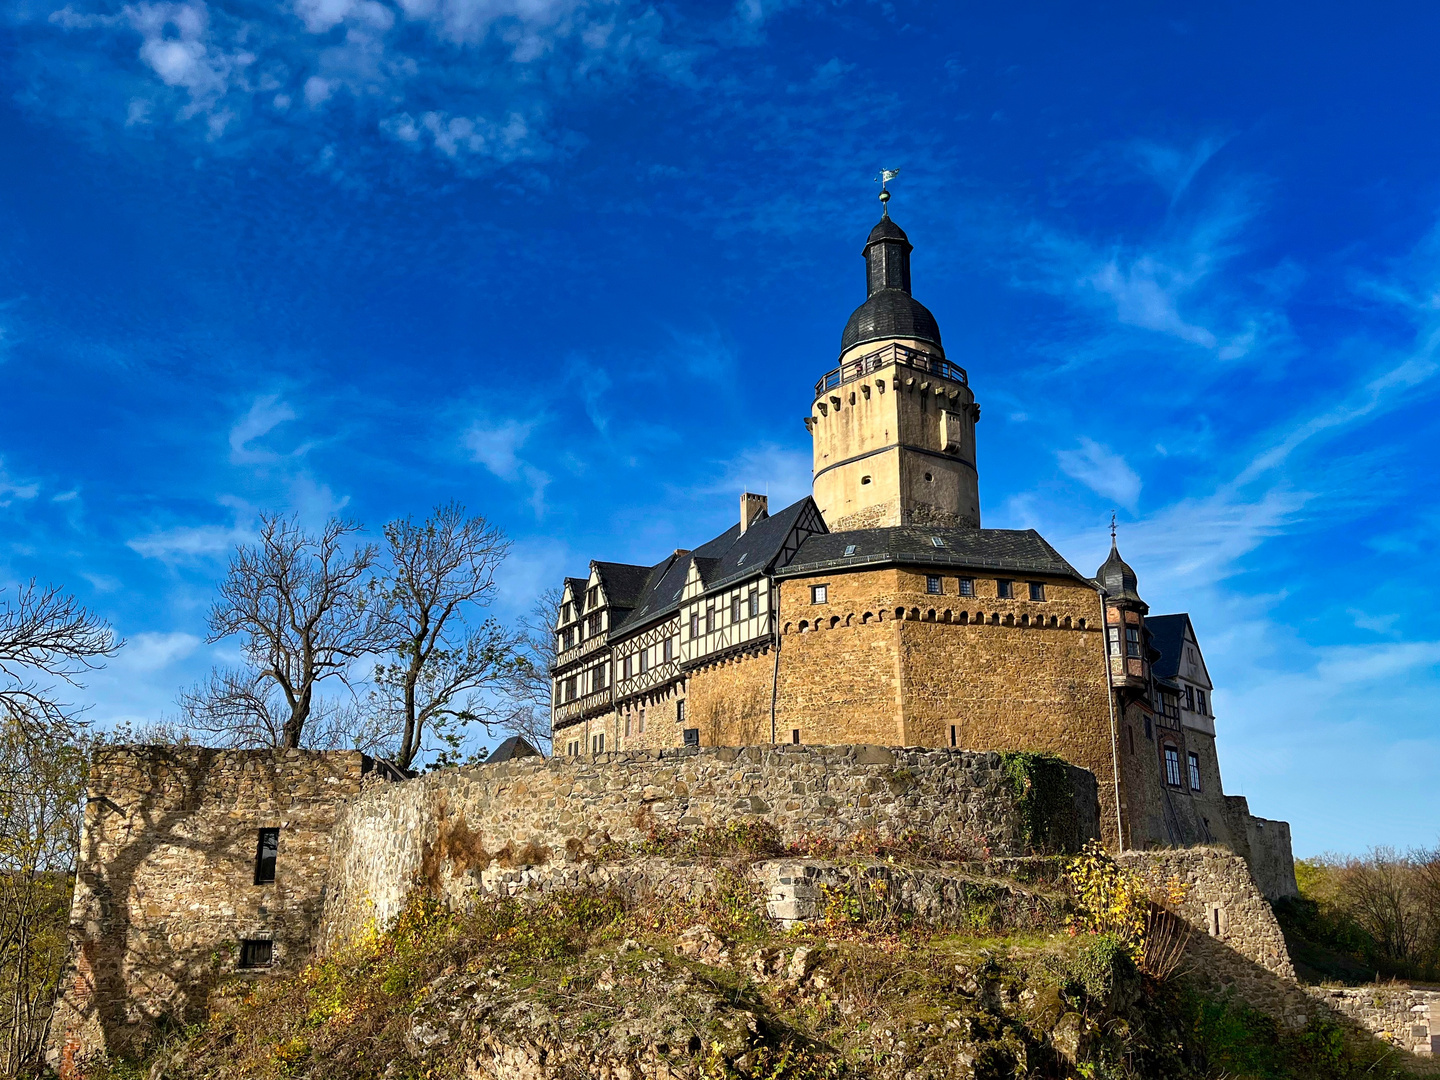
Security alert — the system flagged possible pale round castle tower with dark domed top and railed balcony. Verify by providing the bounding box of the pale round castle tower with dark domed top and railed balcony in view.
[805,201,981,531]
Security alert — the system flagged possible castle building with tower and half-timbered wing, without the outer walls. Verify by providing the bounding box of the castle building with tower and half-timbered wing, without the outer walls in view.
[552,193,1295,896]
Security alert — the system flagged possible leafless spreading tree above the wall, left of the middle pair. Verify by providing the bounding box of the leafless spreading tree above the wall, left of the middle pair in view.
[180,514,383,749]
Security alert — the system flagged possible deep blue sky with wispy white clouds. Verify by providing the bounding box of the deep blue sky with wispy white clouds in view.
[0,0,1440,854]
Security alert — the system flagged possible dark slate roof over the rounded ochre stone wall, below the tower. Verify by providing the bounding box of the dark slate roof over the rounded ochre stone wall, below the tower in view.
[775,526,1090,583]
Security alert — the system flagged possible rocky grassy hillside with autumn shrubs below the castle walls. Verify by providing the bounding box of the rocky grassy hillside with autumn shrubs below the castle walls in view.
[91,844,1422,1080]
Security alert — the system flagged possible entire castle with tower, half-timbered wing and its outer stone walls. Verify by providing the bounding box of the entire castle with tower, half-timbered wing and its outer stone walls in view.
[49,194,1313,1076]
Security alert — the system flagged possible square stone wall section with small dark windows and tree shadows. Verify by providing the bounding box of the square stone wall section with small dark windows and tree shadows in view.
[50,746,372,1071]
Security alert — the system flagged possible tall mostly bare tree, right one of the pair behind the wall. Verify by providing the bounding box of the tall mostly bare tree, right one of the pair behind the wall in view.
[374,503,521,769]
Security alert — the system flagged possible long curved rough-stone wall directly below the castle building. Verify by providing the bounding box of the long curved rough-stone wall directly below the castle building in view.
[320,746,1096,949]
